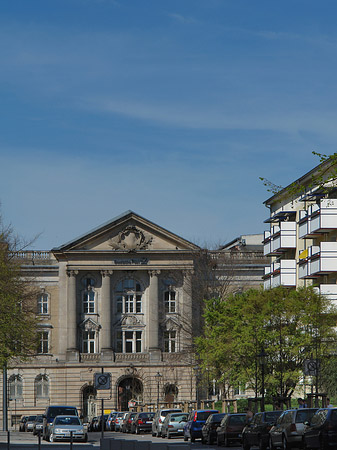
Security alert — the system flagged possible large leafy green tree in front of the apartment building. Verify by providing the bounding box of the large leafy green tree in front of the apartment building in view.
[196,287,336,397]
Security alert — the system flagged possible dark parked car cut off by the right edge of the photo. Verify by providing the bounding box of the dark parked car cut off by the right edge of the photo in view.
[303,408,337,450]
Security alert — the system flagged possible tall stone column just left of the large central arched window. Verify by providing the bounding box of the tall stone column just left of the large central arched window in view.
[99,270,113,361]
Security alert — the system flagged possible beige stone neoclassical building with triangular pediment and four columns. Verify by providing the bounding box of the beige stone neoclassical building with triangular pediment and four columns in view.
[1,211,263,426]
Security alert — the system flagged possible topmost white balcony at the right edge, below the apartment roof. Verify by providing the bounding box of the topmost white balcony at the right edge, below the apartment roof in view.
[299,198,337,239]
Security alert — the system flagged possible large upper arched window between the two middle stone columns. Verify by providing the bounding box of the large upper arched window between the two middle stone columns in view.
[116,278,143,314]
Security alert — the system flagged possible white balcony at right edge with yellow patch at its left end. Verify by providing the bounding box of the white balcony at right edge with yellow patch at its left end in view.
[298,242,337,278]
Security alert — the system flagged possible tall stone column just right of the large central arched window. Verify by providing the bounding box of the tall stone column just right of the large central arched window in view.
[147,270,161,360]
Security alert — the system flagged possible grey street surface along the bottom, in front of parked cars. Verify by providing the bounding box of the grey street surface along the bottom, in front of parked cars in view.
[0,431,241,450]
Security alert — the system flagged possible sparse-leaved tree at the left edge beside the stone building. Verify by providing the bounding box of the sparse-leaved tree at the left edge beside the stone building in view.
[0,218,37,367]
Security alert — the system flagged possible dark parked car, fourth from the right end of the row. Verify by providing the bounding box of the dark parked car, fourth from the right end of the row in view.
[216,413,247,447]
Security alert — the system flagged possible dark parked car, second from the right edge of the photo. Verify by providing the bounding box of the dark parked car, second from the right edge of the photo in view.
[269,408,318,450]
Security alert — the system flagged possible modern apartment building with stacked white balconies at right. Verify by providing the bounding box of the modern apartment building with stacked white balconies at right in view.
[263,161,337,300]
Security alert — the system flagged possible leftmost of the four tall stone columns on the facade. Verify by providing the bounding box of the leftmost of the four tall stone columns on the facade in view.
[67,270,79,360]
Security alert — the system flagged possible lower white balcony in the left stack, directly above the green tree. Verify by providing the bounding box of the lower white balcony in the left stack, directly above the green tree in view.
[264,259,296,289]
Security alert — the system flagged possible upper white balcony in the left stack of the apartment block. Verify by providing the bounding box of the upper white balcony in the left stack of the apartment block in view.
[263,222,296,256]
